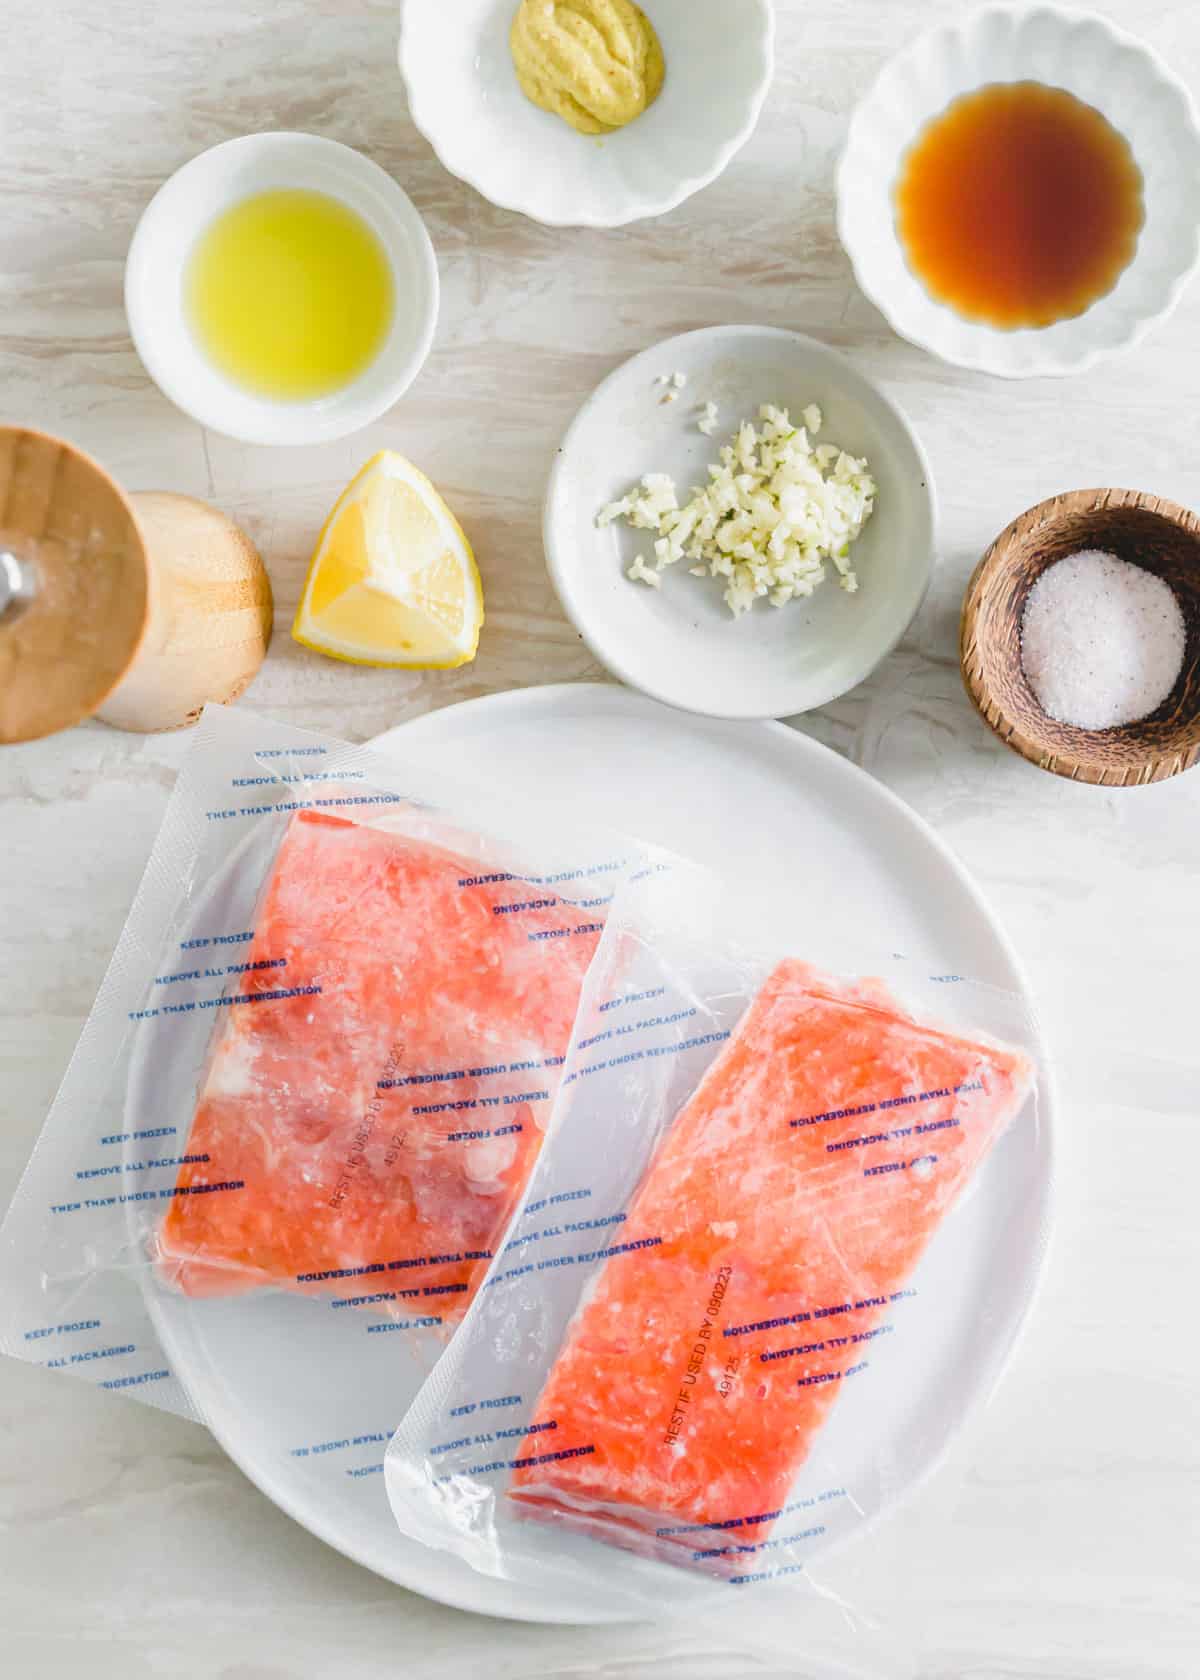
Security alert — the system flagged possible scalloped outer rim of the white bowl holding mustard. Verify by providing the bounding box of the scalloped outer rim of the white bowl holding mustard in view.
[397,0,775,228]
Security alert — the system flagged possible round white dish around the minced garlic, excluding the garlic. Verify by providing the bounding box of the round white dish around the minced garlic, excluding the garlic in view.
[543,326,934,717]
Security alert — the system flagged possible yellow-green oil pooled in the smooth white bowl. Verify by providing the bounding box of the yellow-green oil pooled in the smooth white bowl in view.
[183,188,393,402]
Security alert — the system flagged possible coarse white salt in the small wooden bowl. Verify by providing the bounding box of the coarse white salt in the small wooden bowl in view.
[1020,548,1187,729]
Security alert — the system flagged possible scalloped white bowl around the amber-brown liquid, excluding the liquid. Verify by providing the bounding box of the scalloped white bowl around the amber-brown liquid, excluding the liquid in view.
[837,5,1200,378]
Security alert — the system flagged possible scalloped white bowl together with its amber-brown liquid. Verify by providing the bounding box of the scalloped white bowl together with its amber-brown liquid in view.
[837,3,1200,378]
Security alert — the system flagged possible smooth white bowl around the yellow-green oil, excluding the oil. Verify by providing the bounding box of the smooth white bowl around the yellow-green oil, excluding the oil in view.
[124,133,439,444]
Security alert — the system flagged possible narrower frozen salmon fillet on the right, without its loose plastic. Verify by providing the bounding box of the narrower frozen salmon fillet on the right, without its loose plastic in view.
[511,961,1034,1567]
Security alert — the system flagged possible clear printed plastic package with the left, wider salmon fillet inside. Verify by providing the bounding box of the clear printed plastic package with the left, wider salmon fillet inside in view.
[0,707,640,1424]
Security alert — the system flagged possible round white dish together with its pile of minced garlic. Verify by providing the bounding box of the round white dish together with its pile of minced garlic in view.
[543,326,934,717]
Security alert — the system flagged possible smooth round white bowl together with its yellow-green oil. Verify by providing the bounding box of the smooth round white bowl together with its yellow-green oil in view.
[124,133,439,444]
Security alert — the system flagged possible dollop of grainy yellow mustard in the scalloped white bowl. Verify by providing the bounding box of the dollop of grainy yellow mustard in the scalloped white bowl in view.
[509,0,664,134]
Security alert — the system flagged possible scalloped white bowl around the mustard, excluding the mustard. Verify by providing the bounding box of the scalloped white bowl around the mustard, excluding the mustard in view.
[400,0,775,227]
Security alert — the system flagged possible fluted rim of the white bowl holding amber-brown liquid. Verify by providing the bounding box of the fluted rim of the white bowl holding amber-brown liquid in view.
[835,3,1200,380]
